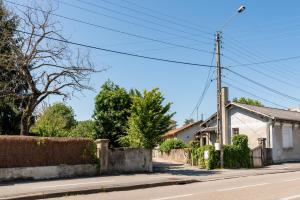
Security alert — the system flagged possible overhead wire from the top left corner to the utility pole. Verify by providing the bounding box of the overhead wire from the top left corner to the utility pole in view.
[4,0,213,54]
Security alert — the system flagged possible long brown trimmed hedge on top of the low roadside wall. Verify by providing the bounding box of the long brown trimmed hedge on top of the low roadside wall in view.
[0,136,96,168]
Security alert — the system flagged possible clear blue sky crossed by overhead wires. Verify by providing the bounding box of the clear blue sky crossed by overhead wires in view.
[15,0,300,124]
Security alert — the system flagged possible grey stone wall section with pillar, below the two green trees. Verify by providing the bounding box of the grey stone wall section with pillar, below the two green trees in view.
[96,140,152,174]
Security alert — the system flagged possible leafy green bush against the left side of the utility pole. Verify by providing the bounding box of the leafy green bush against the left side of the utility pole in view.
[191,145,218,169]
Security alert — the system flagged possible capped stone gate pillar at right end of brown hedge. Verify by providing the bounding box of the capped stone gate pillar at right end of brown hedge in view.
[96,139,109,174]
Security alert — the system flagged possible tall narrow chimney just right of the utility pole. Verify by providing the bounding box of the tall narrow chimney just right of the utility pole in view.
[221,87,231,144]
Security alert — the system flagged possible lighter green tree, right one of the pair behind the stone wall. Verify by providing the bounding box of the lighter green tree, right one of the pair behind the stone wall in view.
[120,88,175,148]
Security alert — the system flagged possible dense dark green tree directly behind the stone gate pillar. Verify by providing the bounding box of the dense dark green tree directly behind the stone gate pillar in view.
[93,81,135,147]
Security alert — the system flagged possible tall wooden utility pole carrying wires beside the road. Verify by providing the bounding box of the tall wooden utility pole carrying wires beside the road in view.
[216,31,224,168]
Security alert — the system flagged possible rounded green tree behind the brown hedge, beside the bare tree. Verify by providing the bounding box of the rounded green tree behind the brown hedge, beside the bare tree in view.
[31,103,76,137]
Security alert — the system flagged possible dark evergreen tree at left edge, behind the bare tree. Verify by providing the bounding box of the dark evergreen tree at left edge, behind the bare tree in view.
[0,0,23,134]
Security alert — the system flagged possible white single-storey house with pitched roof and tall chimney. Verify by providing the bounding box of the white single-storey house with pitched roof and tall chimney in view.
[196,88,300,163]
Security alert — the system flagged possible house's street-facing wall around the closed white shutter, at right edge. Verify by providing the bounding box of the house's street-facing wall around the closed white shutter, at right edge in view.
[272,123,300,163]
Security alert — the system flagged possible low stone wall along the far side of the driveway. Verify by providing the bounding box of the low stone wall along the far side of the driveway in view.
[153,149,190,164]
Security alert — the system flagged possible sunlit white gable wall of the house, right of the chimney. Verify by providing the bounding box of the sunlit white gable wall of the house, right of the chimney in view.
[228,107,268,149]
